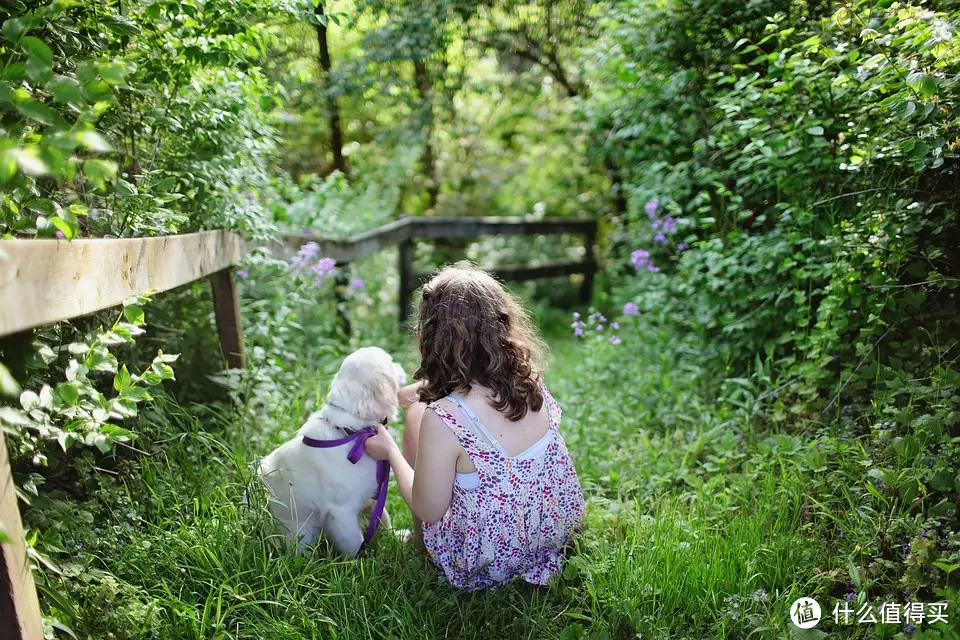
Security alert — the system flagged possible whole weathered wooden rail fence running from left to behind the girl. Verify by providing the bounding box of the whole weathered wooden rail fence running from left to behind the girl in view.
[0,218,597,640]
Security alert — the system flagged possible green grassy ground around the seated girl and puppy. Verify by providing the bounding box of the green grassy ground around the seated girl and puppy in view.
[31,316,956,640]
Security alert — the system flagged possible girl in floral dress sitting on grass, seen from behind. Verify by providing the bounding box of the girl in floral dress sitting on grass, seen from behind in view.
[366,263,584,589]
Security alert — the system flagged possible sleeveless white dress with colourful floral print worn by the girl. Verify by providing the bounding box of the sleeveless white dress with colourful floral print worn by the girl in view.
[423,387,584,590]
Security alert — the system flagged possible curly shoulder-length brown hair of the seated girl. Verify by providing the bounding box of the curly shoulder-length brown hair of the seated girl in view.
[413,262,544,422]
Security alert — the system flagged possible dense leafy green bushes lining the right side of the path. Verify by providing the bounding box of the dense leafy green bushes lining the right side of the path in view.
[591,0,960,620]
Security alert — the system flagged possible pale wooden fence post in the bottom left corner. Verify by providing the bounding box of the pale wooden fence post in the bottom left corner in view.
[0,431,43,640]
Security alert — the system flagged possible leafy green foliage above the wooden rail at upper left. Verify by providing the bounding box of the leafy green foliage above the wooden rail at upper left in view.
[0,0,298,239]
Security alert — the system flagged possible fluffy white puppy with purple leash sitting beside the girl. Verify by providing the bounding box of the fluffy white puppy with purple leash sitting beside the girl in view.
[260,347,406,555]
